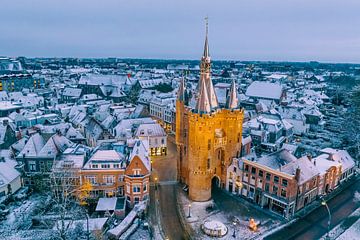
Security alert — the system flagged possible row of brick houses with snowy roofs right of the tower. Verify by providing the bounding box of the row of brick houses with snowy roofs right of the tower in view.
[226,148,356,218]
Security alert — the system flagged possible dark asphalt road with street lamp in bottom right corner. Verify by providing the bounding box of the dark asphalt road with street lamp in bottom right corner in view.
[265,180,360,240]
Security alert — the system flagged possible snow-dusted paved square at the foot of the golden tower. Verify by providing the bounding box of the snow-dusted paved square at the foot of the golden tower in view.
[177,187,281,240]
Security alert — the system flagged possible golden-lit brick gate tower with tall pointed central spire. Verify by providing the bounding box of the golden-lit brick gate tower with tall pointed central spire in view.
[176,19,244,201]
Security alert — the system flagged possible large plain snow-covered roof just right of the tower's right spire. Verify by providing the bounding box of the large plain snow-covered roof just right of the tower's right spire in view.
[245,81,283,100]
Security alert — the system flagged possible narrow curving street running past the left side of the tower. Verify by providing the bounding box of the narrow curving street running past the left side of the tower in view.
[151,136,186,240]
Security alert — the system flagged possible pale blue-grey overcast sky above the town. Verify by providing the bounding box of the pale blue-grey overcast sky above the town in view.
[0,0,360,63]
